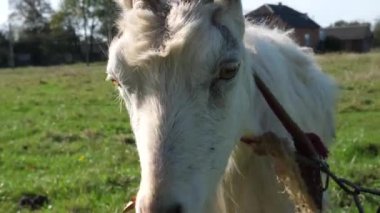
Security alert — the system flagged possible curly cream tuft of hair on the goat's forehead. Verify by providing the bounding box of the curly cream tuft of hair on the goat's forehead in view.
[110,4,222,65]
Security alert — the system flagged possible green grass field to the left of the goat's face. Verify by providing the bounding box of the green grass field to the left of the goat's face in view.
[0,64,139,212]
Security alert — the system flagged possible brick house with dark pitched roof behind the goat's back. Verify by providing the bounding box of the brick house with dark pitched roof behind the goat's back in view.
[245,3,321,49]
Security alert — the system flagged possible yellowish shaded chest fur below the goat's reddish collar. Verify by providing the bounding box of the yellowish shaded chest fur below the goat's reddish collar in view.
[217,144,294,213]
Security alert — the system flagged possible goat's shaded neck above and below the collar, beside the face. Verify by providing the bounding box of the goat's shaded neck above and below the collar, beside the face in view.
[217,60,294,213]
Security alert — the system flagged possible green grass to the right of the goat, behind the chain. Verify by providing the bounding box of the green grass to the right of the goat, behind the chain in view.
[318,51,380,212]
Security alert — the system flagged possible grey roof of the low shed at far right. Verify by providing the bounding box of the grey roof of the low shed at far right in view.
[323,25,372,40]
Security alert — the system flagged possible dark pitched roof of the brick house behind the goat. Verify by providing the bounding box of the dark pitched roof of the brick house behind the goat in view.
[245,3,320,28]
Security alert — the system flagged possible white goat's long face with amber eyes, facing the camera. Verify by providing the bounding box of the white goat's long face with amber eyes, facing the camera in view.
[107,1,247,213]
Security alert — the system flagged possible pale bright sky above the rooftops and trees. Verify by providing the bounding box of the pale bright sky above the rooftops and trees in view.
[0,0,380,27]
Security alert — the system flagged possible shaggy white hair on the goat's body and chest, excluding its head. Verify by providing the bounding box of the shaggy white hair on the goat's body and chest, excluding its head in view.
[215,23,337,213]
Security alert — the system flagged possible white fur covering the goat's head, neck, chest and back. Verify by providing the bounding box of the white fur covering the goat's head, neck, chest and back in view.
[107,1,335,213]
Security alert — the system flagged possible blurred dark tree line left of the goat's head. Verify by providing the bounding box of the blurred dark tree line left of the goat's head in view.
[0,0,118,67]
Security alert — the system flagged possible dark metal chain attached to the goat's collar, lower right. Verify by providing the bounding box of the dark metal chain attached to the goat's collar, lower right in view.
[296,155,380,213]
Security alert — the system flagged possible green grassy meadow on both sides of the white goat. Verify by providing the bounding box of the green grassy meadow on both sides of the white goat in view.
[0,52,380,213]
